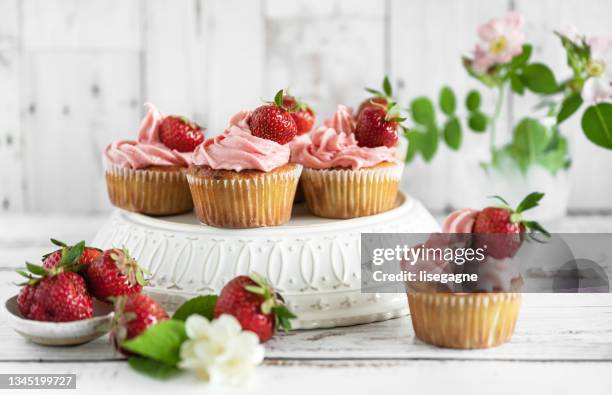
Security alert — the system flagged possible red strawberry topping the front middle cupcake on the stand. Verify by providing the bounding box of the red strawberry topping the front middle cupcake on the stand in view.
[249,89,298,144]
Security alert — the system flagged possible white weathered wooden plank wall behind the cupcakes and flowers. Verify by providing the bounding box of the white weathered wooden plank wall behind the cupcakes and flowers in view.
[0,0,612,213]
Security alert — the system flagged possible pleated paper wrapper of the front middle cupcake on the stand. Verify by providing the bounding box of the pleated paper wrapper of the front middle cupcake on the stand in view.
[187,165,302,228]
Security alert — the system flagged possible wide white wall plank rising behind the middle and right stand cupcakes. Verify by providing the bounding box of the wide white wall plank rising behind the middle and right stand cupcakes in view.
[264,1,386,122]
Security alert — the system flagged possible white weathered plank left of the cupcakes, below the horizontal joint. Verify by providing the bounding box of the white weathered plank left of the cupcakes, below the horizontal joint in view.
[23,51,141,212]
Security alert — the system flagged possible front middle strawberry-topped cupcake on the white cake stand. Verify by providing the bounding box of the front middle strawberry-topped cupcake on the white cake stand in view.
[187,90,302,228]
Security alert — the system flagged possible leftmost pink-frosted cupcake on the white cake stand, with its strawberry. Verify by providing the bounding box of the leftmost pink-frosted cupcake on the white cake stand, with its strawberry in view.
[104,103,204,216]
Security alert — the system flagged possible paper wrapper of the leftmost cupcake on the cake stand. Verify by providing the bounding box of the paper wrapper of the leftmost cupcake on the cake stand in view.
[106,164,193,215]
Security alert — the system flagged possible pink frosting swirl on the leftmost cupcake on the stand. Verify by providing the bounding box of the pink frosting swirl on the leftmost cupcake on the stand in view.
[104,103,191,169]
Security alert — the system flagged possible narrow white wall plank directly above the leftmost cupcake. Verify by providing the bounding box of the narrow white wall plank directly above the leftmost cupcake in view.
[142,0,212,126]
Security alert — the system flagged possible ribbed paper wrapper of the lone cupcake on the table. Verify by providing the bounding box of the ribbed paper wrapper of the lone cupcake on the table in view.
[408,292,521,349]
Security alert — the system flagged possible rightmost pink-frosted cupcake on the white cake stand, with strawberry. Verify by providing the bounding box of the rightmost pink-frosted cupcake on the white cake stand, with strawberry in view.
[293,105,403,218]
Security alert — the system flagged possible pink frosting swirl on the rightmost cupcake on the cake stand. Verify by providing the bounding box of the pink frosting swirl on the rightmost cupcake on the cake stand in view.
[292,106,395,170]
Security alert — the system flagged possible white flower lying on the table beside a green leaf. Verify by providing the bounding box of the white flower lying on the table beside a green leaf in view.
[179,314,264,384]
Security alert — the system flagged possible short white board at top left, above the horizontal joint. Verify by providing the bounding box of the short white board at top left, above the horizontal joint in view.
[23,0,141,50]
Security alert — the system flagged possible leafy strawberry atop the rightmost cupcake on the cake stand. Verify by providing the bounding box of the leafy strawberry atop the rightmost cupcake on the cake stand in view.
[355,77,405,148]
